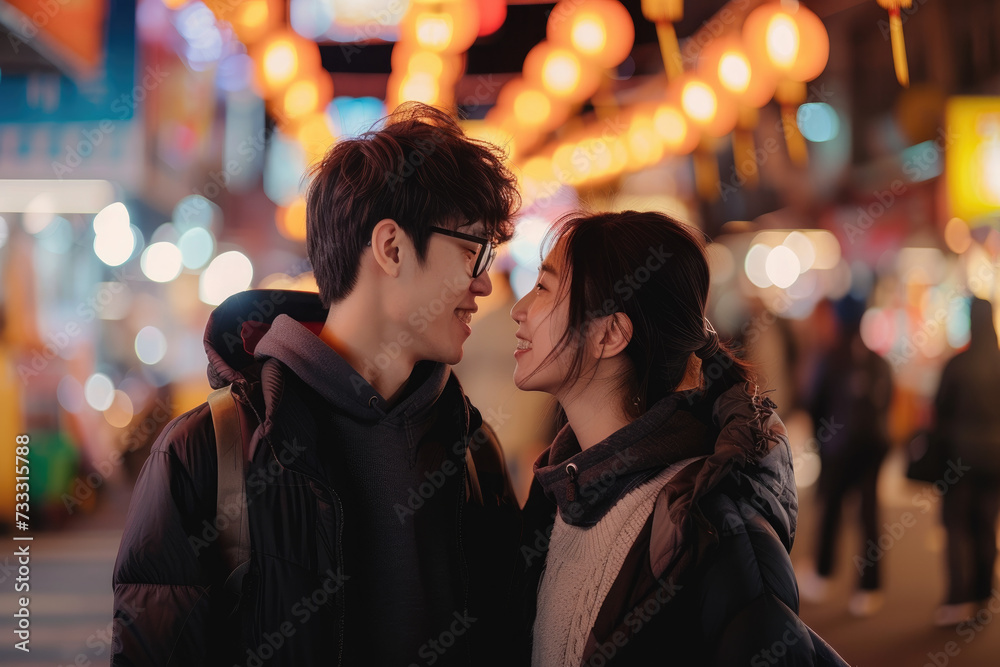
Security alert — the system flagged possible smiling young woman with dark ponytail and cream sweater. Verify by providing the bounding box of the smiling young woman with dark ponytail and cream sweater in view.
[511,211,846,667]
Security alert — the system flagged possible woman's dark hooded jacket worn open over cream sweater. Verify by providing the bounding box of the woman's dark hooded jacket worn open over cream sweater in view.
[518,386,846,667]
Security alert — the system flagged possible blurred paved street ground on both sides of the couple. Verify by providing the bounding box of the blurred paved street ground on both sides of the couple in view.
[0,452,1000,667]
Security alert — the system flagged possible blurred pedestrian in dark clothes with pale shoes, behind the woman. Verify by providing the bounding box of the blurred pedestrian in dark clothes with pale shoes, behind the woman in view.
[799,297,892,616]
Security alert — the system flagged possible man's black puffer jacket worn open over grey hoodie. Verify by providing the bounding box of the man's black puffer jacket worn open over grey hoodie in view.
[112,292,520,667]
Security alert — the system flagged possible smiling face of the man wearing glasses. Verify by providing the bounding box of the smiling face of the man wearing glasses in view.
[401,223,493,364]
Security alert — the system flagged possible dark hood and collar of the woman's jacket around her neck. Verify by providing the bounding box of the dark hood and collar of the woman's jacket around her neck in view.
[535,385,798,549]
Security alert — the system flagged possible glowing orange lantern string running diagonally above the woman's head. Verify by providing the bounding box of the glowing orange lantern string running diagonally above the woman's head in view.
[518,3,829,202]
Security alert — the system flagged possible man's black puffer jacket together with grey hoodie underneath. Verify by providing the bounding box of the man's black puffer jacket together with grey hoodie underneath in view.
[112,291,520,667]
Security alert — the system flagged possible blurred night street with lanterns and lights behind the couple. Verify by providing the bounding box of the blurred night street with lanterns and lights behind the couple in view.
[0,0,1000,667]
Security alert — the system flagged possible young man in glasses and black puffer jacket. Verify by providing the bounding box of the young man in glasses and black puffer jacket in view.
[112,105,520,667]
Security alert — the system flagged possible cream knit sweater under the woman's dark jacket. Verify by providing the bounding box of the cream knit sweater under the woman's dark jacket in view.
[531,459,694,667]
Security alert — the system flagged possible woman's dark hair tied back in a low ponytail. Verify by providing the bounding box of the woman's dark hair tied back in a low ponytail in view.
[546,211,753,416]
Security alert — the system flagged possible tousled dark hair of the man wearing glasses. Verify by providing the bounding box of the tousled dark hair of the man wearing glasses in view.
[306,103,520,306]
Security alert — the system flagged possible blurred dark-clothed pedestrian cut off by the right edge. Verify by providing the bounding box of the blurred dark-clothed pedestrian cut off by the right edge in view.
[932,299,1000,626]
